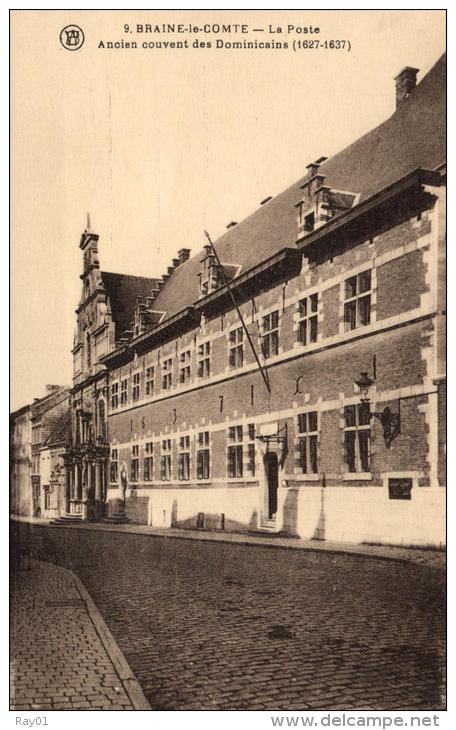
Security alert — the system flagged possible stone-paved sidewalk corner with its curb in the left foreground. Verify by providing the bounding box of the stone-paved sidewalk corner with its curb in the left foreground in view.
[10,560,151,711]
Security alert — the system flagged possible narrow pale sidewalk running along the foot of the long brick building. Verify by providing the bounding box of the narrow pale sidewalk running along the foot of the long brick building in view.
[12,516,446,570]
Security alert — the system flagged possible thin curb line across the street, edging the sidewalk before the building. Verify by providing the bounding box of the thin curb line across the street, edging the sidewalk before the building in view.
[23,522,446,570]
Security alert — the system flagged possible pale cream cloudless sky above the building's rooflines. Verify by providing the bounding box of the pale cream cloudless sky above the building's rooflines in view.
[11,10,445,410]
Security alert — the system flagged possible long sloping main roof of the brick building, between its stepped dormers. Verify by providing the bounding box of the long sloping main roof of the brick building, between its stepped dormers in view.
[154,55,446,318]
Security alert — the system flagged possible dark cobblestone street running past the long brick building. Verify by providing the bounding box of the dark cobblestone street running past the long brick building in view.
[16,526,445,710]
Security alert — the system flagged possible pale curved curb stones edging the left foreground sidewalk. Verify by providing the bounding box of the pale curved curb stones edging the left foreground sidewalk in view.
[41,560,152,710]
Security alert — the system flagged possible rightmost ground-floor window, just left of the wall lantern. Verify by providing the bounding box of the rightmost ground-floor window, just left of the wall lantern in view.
[344,403,371,473]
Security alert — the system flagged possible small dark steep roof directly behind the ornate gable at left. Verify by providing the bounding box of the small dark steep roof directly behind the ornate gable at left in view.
[101,271,158,338]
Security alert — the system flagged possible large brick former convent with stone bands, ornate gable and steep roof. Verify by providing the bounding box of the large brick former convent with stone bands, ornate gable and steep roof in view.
[68,57,446,545]
